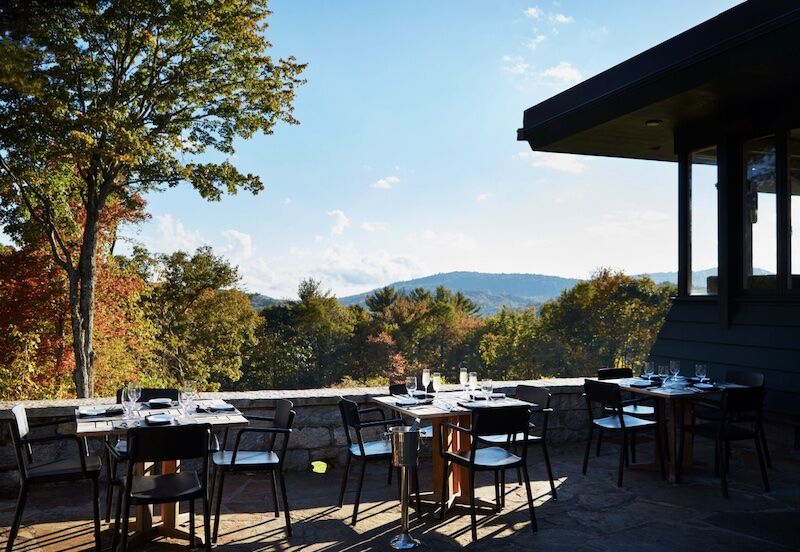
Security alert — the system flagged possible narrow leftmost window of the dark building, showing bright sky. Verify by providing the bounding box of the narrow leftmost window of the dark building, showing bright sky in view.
[689,147,717,295]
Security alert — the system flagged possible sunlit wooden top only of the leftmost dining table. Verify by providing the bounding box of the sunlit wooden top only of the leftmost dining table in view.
[75,400,248,437]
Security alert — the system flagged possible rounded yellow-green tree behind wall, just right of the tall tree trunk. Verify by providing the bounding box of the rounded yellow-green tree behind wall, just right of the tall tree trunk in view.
[149,247,258,390]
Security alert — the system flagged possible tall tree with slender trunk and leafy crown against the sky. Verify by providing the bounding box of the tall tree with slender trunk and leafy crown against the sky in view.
[0,0,305,397]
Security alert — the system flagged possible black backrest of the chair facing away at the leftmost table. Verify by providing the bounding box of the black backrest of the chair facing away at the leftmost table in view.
[128,424,211,464]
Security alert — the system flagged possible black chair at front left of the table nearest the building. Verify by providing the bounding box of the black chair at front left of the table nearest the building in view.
[583,379,666,487]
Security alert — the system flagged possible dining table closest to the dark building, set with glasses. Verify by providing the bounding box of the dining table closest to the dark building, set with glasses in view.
[603,375,742,483]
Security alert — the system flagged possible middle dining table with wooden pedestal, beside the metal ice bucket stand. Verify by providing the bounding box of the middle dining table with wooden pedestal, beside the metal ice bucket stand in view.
[372,389,538,507]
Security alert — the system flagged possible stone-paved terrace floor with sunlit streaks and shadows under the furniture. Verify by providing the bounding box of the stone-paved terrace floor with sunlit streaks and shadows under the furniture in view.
[0,441,800,552]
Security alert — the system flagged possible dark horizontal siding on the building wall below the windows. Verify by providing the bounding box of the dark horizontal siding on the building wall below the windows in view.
[651,298,800,415]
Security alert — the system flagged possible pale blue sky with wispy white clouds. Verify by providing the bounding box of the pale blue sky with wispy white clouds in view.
[120,0,737,297]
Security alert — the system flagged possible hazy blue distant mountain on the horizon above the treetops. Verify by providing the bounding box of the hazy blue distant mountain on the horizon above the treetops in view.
[339,272,580,315]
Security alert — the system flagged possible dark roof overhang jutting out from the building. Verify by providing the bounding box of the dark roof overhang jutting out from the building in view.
[517,0,800,161]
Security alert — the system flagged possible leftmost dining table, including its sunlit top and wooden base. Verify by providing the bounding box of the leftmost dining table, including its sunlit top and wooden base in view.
[75,400,248,545]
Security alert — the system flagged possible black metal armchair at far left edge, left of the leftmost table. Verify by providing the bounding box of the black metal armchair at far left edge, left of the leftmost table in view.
[6,405,102,552]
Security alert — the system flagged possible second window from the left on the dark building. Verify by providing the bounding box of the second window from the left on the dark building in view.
[743,136,778,290]
